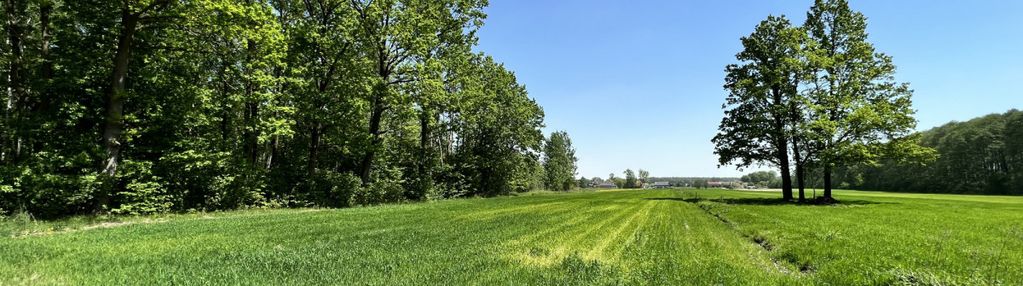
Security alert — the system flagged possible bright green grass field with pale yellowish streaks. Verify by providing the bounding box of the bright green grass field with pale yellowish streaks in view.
[0,190,1023,285]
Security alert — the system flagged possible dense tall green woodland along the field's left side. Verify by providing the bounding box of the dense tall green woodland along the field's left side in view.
[0,0,574,218]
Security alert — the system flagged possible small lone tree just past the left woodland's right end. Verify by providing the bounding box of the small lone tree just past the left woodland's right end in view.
[543,131,577,191]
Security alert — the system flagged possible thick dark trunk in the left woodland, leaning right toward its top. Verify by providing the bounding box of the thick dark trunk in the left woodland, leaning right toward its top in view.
[102,8,139,177]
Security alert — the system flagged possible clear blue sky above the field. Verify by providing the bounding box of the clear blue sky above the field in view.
[479,0,1023,178]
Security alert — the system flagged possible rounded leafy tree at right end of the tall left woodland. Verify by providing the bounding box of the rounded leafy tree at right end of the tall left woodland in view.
[453,55,543,196]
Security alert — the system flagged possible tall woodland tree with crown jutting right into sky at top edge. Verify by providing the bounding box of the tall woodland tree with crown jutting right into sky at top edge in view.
[352,0,485,184]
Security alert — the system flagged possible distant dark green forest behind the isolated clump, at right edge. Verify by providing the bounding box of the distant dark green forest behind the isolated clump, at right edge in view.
[838,109,1023,195]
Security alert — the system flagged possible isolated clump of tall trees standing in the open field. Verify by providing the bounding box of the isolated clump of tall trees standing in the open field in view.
[712,0,933,202]
